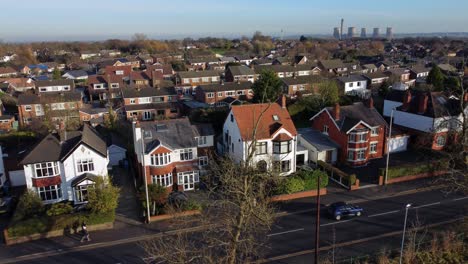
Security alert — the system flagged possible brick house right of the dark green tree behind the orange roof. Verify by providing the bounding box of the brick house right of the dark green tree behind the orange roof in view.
[281,75,324,98]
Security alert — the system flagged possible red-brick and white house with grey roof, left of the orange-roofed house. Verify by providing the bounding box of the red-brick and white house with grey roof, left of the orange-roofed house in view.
[133,118,214,191]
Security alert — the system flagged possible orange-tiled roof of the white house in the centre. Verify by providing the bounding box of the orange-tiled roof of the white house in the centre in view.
[226,103,297,140]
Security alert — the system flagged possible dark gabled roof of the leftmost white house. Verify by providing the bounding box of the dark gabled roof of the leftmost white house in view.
[21,125,107,164]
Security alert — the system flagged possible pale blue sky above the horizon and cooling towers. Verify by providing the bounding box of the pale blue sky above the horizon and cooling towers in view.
[0,0,468,42]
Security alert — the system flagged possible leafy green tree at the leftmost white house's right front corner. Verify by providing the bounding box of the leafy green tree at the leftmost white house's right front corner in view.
[87,176,120,213]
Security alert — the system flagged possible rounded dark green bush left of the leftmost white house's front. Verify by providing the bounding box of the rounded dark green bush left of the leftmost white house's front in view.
[13,190,44,221]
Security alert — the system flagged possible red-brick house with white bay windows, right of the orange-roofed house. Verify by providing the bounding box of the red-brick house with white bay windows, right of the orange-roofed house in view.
[310,101,388,167]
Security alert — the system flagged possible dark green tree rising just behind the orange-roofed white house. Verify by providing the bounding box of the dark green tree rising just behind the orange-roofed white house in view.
[252,70,282,103]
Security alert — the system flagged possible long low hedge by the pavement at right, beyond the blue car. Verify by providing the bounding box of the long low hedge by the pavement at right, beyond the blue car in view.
[380,160,448,180]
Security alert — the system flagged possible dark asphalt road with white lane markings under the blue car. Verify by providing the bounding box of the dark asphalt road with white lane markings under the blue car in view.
[4,190,468,264]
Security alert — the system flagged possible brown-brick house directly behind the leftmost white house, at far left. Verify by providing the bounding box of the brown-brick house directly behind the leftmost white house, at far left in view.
[18,92,82,129]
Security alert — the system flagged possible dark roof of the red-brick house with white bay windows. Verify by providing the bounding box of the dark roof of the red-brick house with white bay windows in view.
[327,102,387,132]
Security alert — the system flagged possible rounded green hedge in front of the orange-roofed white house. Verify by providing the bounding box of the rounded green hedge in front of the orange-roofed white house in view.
[275,170,328,195]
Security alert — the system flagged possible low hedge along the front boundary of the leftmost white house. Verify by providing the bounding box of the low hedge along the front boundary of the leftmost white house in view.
[8,212,115,237]
